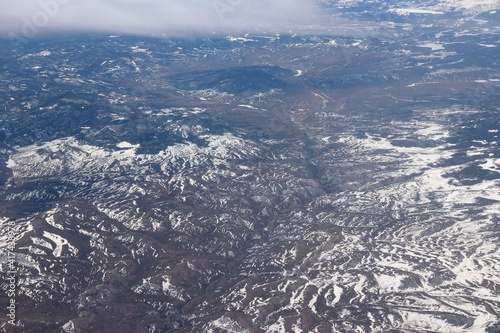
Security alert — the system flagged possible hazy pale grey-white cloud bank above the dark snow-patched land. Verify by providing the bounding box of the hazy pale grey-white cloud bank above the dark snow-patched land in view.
[0,0,318,34]
